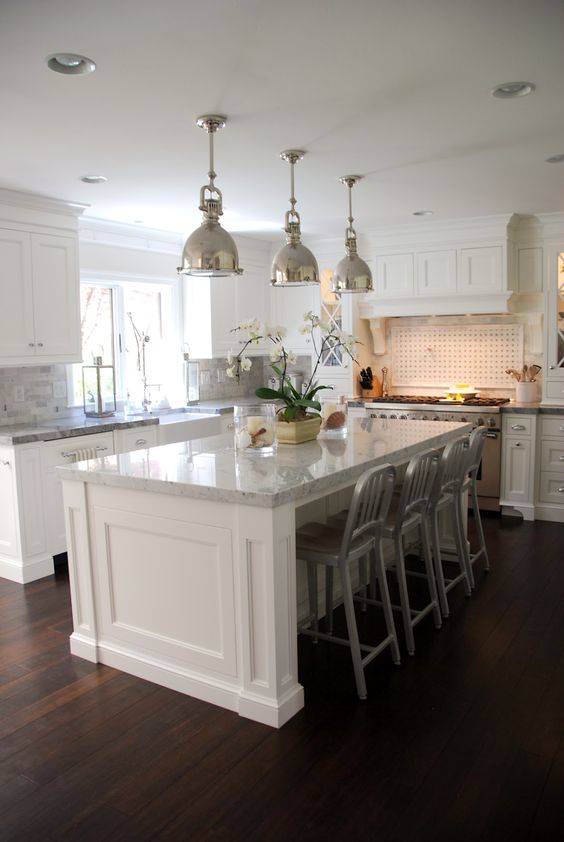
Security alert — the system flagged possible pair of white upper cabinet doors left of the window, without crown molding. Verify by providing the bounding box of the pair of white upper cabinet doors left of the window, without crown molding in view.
[0,229,81,365]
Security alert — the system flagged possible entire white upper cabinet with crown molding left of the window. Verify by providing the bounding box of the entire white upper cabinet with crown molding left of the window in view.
[0,191,85,366]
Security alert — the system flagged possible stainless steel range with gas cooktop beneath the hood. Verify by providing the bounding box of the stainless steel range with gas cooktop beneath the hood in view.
[365,395,509,511]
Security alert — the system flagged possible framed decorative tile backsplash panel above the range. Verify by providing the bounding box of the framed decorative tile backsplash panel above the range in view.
[392,324,523,389]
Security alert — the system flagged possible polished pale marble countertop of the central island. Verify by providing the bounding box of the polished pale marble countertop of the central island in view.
[57,418,471,508]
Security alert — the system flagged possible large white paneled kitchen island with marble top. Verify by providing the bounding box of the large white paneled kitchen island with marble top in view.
[58,419,470,727]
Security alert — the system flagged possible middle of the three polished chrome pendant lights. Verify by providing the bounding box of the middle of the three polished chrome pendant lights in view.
[270,149,319,287]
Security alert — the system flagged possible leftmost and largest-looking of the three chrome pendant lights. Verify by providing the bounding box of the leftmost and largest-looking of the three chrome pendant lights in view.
[178,114,243,278]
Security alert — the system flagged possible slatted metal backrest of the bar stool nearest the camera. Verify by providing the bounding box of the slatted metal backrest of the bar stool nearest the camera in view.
[341,464,396,558]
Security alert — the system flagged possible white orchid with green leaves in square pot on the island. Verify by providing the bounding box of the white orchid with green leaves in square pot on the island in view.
[226,311,356,444]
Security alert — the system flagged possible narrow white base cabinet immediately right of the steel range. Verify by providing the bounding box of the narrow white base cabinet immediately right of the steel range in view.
[500,413,536,520]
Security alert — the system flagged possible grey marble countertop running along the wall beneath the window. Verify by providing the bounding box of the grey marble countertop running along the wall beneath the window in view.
[0,407,215,446]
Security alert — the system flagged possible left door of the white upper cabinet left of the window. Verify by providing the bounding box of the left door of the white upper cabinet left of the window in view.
[0,230,35,358]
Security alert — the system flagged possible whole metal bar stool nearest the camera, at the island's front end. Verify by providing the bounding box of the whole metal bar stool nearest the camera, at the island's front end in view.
[296,465,400,699]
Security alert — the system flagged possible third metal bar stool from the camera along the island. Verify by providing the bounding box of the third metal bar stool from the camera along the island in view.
[427,436,472,617]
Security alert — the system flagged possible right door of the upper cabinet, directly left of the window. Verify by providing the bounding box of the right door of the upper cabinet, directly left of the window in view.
[31,234,82,361]
